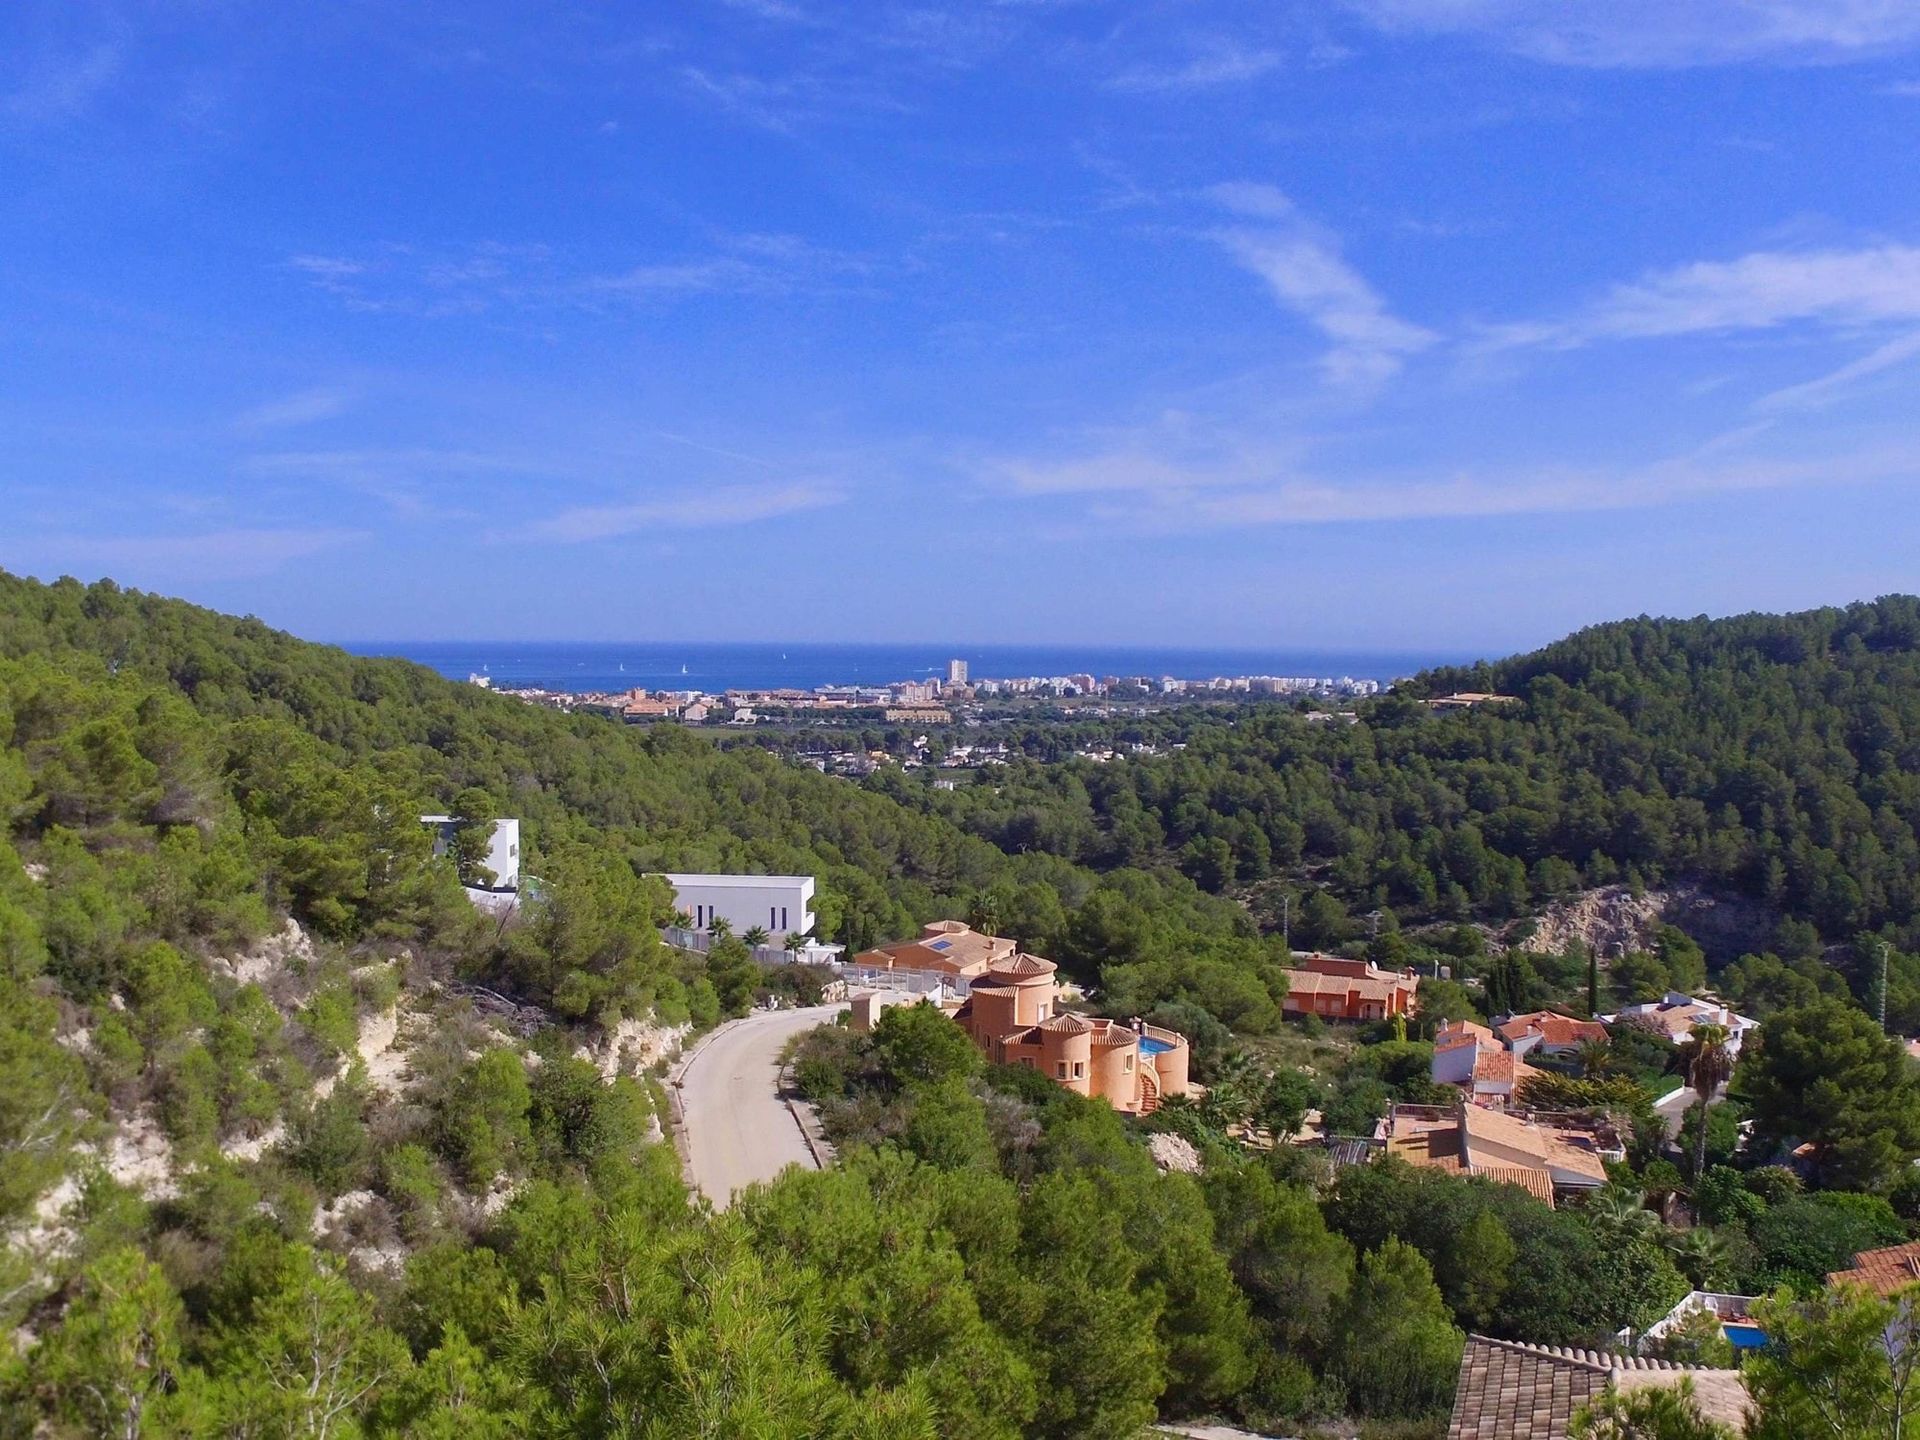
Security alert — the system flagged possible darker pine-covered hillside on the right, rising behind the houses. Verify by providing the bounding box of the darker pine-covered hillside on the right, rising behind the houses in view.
[897,597,1920,963]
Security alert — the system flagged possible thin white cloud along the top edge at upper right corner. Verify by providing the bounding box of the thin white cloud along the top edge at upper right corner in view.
[1346,0,1920,67]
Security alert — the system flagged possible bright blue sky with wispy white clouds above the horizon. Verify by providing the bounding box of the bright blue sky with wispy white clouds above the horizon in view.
[0,0,1920,651]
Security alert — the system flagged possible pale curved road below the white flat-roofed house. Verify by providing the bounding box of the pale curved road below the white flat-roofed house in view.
[674,1004,845,1210]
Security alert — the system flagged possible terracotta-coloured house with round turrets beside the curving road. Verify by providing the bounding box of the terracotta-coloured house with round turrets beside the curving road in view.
[954,952,1188,1116]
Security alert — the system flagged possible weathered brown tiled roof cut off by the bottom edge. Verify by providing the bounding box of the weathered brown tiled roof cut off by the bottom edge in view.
[1446,1334,1747,1440]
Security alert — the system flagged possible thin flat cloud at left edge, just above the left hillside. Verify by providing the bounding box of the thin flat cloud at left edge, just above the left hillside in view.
[0,526,365,584]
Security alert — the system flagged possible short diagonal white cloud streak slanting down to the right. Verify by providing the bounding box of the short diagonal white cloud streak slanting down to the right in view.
[1210,184,1438,386]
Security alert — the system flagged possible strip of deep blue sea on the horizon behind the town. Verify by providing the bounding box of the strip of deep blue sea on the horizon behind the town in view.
[346,639,1476,691]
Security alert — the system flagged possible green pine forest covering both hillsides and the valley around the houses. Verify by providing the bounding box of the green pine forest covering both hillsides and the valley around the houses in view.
[0,574,1920,1440]
